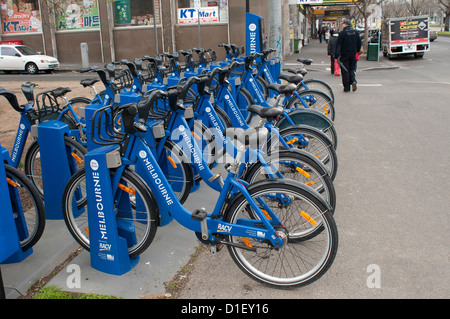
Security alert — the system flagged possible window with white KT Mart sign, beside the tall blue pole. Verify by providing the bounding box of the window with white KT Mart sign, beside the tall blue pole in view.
[177,0,228,24]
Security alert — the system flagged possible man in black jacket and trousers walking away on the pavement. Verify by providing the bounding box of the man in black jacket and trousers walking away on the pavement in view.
[336,19,361,92]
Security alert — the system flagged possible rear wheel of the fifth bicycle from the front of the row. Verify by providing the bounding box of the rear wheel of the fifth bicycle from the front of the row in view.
[285,89,336,121]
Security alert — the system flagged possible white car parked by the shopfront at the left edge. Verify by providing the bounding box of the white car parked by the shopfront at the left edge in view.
[0,44,59,74]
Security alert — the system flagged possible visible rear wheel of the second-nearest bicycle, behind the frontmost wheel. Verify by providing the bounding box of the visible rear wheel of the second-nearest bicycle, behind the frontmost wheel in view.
[243,149,336,212]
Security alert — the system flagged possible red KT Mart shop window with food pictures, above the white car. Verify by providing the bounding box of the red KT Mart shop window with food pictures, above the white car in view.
[0,0,42,34]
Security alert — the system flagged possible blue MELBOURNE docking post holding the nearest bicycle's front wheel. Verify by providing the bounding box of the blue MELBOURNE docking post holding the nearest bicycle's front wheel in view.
[81,105,139,276]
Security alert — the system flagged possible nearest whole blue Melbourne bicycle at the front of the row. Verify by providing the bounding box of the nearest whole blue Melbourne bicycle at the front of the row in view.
[63,85,338,287]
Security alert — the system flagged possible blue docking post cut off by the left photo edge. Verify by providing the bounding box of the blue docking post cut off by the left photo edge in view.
[0,145,33,264]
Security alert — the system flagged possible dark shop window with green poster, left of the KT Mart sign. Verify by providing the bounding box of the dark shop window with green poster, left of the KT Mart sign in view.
[114,0,161,26]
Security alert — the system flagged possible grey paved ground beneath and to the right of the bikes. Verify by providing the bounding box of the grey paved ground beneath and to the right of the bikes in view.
[0,37,450,300]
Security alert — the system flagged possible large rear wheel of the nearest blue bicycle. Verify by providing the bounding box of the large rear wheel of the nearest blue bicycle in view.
[225,180,338,287]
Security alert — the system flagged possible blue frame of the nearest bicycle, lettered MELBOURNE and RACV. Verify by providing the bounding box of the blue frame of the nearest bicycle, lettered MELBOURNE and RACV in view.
[97,106,288,247]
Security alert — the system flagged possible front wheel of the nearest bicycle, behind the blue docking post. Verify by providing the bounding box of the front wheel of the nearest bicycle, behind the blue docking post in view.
[63,169,158,258]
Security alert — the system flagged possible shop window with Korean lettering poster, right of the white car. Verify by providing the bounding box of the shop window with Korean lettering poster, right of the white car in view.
[54,0,100,31]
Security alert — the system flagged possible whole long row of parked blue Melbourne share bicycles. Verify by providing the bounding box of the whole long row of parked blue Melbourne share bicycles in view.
[0,44,338,286]
